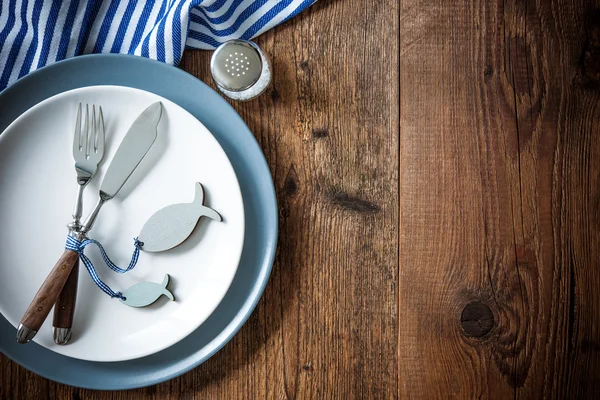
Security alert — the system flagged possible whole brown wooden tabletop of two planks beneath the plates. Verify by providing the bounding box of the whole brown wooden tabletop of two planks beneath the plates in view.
[0,0,600,399]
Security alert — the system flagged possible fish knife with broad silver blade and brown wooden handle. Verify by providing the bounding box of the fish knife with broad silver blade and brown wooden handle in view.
[17,102,162,343]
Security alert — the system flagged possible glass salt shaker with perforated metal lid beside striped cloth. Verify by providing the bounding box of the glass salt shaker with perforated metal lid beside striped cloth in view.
[210,39,271,100]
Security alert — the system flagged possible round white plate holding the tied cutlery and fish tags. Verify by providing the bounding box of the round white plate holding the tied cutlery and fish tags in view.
[0,86,244,361]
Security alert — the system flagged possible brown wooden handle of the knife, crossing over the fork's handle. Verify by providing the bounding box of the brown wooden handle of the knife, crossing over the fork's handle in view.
[21,250,79,331]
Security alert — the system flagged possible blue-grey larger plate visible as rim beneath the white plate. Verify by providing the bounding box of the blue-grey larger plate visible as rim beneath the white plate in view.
[0,54,278,390]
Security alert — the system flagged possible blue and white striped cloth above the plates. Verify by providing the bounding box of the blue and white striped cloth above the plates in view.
[0,0,316,90]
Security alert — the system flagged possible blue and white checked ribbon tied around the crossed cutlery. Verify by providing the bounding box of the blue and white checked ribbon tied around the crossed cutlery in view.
[65,235,141,300]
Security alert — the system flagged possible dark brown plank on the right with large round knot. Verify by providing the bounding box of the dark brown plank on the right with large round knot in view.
[399,0,600,399]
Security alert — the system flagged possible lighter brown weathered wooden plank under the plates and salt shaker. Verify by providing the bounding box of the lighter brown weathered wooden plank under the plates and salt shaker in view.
[1,0,399,400]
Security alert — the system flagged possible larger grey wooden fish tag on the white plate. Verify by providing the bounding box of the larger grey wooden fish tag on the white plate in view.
[138,182,222,252]
